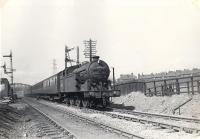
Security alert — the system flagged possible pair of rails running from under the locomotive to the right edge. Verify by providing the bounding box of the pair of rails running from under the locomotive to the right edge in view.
[81,108,200,134]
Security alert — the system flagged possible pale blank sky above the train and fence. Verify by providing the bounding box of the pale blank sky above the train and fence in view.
[0,0,200,84]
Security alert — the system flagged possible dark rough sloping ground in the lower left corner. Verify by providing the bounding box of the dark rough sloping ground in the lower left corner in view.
[0,101,61,139]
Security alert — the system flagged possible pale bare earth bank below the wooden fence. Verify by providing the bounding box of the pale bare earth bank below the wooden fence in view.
[112,92,200,118]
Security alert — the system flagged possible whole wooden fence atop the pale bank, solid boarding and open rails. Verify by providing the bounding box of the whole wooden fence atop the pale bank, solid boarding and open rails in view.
[115,75,200,96]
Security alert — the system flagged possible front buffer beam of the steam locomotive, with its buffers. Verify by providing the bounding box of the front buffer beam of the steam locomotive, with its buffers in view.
[84,90,120,98]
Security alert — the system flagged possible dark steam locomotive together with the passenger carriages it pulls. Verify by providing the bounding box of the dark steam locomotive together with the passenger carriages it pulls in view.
[31,56,120,107]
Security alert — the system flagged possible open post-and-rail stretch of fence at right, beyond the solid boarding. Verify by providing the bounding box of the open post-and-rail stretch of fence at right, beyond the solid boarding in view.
[144,75,200,96]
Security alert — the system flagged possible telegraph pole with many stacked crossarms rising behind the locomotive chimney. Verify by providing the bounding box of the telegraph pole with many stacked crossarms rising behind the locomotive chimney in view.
[84,39,97,62]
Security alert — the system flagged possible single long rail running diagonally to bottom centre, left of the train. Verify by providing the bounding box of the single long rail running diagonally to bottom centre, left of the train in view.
[26,97,145,139]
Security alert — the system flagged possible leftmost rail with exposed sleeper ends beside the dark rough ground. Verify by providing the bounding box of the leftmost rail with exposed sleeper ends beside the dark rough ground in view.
[24,101,77,139]
